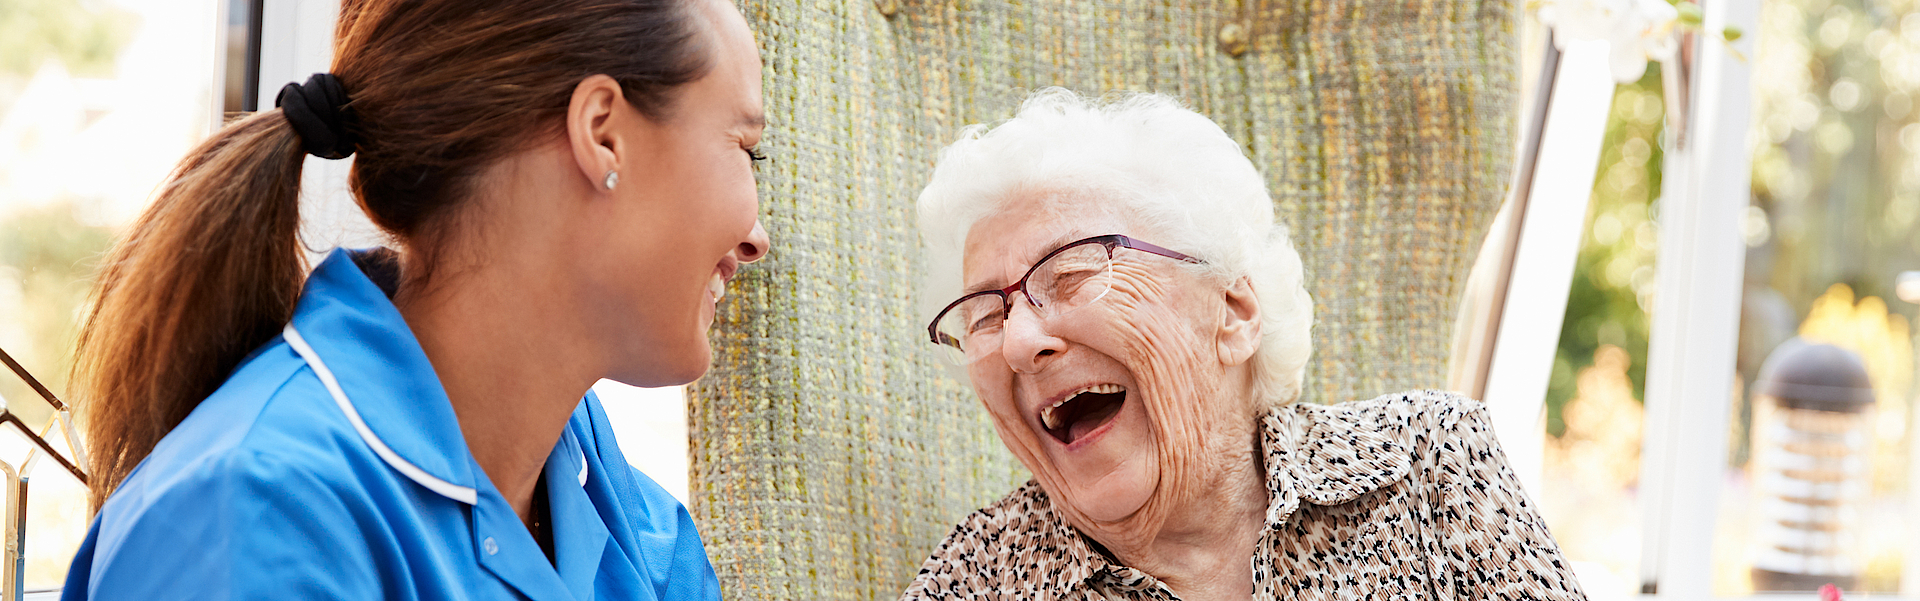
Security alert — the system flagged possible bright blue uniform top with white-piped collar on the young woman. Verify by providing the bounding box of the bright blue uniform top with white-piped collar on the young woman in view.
[61,252,720,601]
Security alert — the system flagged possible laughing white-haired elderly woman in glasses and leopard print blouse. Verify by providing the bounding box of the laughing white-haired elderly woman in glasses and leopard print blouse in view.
[904,90,1582,599]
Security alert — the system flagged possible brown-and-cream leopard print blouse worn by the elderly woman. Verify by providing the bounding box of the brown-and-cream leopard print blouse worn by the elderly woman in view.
[902,390,1586,601]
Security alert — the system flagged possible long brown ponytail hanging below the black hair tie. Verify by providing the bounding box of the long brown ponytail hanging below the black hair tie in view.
[73,109,307,511]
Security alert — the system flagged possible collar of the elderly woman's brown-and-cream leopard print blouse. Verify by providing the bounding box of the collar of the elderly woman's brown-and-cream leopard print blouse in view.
[1014,397,1413,599]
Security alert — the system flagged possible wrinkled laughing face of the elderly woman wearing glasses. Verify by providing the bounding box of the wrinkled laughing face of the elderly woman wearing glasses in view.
[964,192,1248,528]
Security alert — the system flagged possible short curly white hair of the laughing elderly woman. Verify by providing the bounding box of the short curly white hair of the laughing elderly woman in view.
[920,88,1313,405]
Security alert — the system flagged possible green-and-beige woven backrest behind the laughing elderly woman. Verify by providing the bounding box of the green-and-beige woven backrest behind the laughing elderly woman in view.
[689,0,1519,599]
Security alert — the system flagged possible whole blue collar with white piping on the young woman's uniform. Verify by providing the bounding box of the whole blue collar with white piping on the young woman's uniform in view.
[284,250,611,599]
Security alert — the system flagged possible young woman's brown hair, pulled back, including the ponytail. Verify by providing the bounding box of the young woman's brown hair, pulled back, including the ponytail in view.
[73,0,712,511]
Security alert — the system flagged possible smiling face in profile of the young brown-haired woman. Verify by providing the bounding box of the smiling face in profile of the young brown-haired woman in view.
[595,2,768,386]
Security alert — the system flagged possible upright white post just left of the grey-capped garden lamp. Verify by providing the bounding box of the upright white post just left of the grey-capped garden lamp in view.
[1640,0,1759,599]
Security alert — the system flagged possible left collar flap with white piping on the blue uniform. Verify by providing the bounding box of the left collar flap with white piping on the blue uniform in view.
[284,250,478,505]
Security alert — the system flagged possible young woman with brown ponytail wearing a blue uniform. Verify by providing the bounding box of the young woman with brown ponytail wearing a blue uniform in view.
[63,0,768,599]
